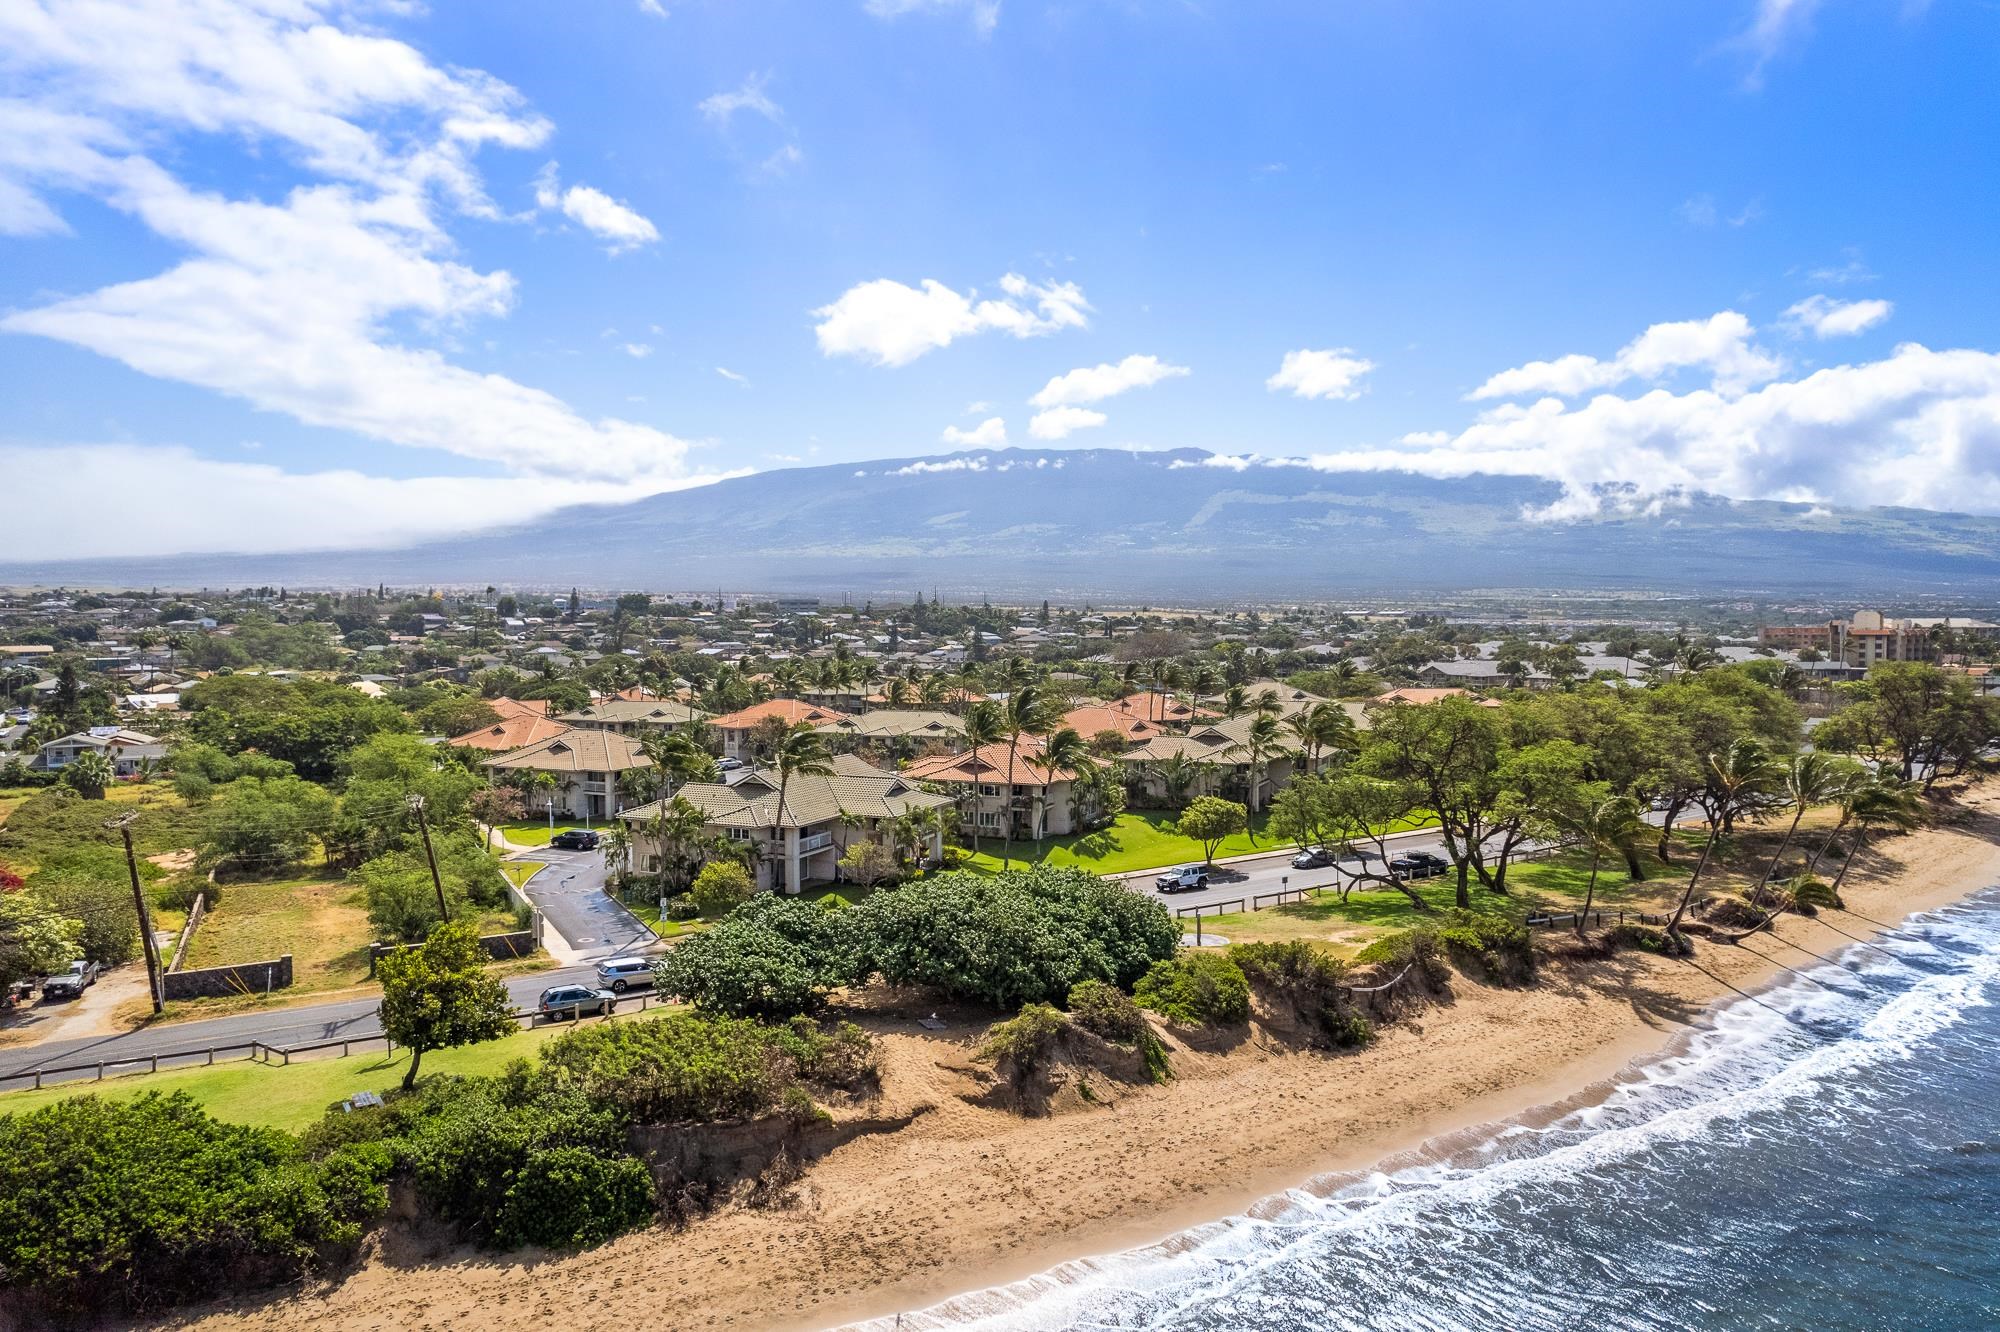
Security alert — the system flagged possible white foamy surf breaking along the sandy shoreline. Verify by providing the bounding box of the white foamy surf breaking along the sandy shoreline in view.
[852,890,2000,1332]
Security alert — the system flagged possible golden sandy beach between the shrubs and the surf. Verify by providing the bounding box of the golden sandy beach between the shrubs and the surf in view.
[152,782,2000,1332]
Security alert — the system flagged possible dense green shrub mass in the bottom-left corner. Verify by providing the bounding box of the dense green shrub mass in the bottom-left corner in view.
[0,1092,388,1316]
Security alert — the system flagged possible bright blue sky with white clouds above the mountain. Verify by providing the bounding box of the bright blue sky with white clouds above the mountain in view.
[0,0,2000,560]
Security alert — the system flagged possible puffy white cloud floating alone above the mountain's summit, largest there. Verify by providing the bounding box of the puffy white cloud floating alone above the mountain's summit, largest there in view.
[812,272,1090,366]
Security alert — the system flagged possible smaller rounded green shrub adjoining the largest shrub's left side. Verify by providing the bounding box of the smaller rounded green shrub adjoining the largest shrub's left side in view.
[652,892,852,1018]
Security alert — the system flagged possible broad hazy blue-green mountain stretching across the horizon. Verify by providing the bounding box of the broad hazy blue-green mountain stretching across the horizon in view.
[0,448,2000,600]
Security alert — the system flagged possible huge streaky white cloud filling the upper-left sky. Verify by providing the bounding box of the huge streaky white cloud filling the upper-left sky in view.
[0,0,688,492]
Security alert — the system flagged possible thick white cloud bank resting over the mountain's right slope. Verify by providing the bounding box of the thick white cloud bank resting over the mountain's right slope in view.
[1310,332,2000,518]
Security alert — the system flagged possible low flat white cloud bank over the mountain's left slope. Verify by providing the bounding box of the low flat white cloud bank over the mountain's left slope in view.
[0,444,720,560]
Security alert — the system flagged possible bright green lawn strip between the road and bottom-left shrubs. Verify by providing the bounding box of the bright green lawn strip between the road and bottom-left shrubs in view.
[0,1006,670,1130]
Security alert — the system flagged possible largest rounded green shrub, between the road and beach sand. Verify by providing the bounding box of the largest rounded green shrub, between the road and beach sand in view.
[842,866,1180,1010]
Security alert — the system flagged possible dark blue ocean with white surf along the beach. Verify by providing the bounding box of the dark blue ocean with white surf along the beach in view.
[872,890,2000,1332]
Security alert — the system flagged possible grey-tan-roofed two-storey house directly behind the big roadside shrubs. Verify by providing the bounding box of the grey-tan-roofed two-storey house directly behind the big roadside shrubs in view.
[620,754,952,894]
